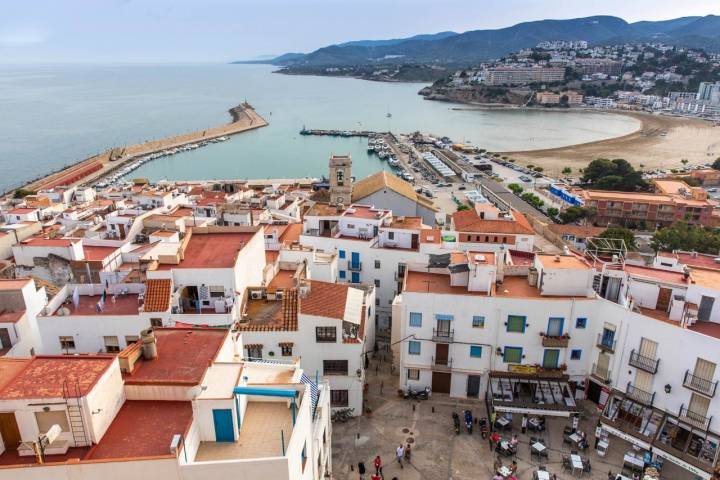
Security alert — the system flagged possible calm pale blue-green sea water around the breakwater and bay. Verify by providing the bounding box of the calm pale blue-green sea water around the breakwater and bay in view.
[0,65,638,191]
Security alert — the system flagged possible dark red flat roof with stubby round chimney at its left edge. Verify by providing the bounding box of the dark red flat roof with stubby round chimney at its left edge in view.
[123,328,229,385]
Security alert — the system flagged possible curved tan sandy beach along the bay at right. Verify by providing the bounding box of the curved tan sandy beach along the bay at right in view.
[503,111,720,175]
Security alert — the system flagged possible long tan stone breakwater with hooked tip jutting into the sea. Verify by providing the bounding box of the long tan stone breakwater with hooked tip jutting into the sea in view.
[23,102,268,191]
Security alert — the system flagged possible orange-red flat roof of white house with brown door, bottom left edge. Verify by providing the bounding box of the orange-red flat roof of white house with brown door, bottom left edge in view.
[0,355,115,400]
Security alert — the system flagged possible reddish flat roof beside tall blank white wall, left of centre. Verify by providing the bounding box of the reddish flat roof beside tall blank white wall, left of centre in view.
[158,232,257,270]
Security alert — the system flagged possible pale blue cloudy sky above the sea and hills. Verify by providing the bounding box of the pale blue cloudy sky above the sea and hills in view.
[0,0,720,63]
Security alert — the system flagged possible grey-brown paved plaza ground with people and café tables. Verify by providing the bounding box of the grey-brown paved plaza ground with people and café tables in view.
[332,360,693,480]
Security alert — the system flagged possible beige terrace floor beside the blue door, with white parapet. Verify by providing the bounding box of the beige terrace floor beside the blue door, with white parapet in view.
[195,402,293,462]
